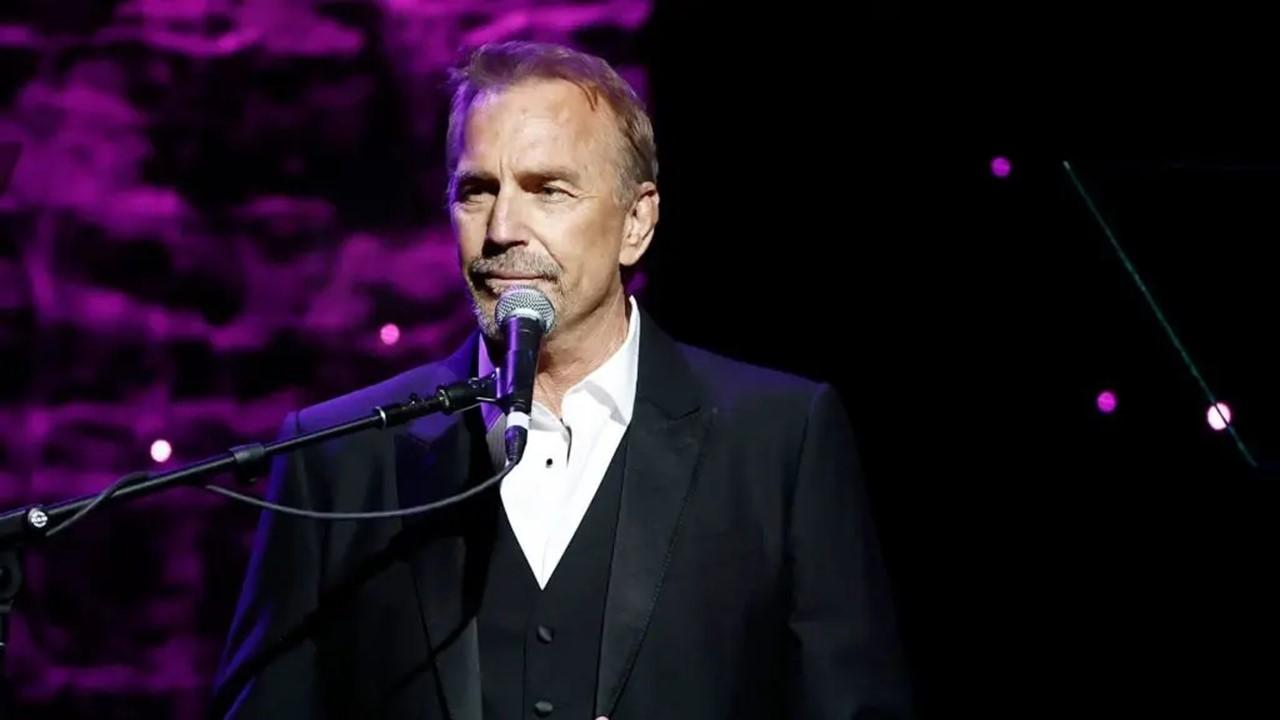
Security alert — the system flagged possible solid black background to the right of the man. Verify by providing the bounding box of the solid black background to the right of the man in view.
[650,3,1280,717]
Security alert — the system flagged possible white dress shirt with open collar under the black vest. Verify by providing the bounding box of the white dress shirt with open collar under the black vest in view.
[479,297,640,588]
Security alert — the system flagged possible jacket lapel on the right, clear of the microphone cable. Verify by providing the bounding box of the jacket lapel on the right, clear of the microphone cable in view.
[595,314,713,716]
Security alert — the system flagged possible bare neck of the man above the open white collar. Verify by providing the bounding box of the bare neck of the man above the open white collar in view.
[534,288,630,415]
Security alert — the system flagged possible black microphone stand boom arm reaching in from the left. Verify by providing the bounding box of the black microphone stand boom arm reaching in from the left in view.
[0,373,497,707]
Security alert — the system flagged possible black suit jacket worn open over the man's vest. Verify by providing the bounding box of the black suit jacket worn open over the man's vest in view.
[212,308,908,720]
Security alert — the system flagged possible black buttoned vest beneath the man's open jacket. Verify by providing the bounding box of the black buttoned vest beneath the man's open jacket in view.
[476,436,627,720]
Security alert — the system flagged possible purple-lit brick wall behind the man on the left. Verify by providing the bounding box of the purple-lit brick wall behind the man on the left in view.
[0,0,650,719]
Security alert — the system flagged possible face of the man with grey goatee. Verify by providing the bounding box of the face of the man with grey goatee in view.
[451,79,648,337]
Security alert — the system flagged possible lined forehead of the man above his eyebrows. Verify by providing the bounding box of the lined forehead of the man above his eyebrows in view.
[458,79,616,172]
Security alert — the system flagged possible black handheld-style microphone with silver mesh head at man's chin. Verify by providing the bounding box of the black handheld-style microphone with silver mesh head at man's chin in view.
[493,286,556,465]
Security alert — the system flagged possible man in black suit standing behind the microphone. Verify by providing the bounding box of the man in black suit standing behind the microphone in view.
[215,44,906,720]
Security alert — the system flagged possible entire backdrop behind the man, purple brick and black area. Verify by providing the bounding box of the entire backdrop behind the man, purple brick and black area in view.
[0,0,1280,717]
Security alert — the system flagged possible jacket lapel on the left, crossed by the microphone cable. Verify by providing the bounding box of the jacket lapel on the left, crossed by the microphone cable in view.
[396,337,494,720]
